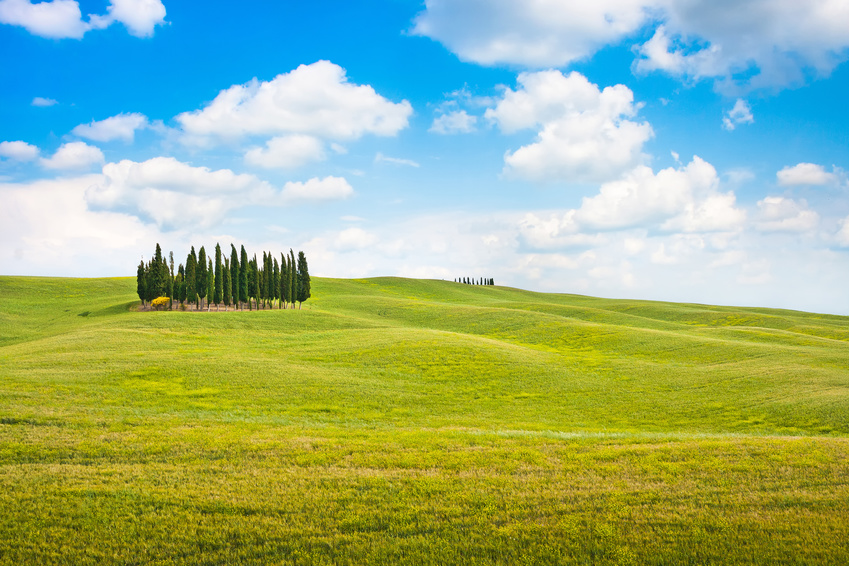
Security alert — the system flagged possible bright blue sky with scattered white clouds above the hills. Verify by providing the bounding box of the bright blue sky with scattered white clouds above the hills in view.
[0,0,849,315]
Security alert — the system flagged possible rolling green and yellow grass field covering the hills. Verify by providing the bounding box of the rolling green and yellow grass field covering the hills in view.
[0,277,849,565]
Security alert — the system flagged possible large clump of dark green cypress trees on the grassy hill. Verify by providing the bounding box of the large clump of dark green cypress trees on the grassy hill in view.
[136,244,310,310]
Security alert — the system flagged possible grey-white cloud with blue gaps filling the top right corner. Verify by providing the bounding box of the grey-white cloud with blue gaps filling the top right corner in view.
[637,0,849,90]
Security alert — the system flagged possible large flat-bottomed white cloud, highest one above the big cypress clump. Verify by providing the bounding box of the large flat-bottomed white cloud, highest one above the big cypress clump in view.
[177,61,413,142]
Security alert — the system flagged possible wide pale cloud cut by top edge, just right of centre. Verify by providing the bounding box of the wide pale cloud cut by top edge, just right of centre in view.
[413,0,647,68]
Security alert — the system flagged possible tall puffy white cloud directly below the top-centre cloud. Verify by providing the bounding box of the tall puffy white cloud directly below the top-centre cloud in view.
[485,71,653,182]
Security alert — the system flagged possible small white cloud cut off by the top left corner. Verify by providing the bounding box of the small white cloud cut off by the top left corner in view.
[0,0,165,39]
